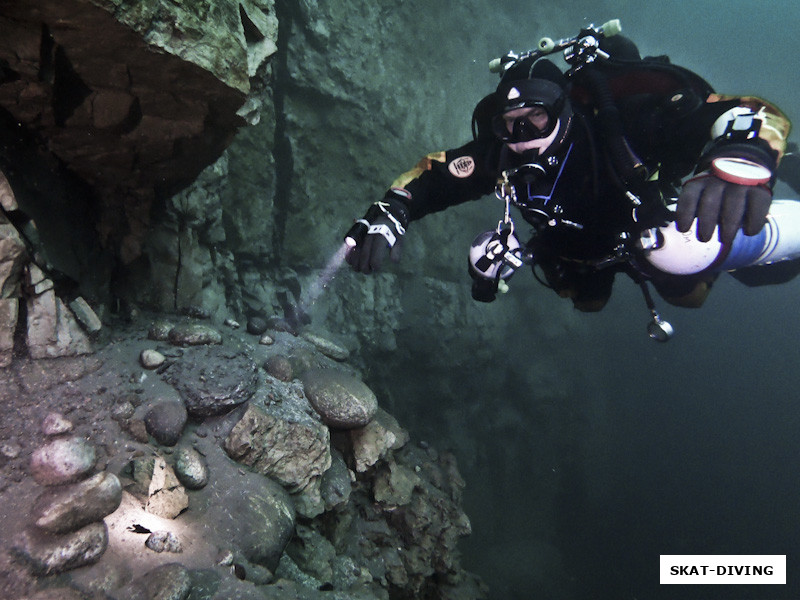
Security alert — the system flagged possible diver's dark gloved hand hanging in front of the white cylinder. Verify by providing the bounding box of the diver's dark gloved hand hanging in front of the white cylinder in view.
[675,173,772,244]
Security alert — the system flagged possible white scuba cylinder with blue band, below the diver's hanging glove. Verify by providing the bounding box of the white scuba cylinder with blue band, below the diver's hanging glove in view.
[640,200,800,275]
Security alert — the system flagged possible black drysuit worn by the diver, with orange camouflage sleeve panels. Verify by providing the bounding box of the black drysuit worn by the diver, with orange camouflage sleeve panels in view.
[386,59,788,311]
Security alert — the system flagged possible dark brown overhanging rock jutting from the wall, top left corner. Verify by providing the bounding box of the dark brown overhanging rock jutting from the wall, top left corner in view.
[0,0,277,270]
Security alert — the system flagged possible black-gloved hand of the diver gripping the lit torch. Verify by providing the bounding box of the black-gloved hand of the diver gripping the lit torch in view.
[345,198,408,274]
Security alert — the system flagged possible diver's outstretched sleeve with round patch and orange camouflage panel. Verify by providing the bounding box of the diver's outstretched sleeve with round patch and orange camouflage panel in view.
[386,141,496,221]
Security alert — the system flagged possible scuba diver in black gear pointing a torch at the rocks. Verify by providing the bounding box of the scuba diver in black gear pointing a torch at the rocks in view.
[345,20,800,341]
